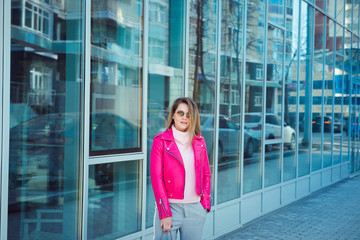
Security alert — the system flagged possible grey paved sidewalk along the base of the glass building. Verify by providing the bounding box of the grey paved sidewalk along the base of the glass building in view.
[218,175,360,240]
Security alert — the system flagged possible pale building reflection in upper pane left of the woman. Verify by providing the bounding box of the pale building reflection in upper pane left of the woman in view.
[91,1,142,124]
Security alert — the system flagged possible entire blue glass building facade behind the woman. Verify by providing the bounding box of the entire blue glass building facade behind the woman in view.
[0,0,360,240]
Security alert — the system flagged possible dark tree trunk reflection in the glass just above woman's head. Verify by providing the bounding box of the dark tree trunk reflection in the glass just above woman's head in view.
[193,0,216,101]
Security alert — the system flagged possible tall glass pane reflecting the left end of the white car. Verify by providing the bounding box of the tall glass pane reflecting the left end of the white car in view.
[243,0,265,194]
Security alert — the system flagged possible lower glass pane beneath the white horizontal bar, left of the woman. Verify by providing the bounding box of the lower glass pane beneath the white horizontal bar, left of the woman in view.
[87,161,142,240]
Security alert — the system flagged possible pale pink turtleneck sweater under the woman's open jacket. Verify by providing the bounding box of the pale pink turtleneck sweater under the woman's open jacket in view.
[169,125,201,203]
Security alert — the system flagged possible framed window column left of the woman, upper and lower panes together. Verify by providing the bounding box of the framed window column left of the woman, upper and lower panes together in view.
[85,0,143,239]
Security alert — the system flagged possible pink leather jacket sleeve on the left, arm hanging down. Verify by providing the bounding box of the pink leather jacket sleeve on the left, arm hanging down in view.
[150,137,172,220]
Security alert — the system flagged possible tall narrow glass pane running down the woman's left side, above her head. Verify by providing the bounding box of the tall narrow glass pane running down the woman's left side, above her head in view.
[146,0,186,227]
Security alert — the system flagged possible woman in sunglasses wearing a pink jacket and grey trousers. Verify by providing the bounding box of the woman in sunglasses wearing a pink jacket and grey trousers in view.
[150,98,211,240]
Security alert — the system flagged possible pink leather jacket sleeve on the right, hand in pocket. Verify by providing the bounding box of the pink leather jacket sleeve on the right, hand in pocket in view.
[200,138,211,212]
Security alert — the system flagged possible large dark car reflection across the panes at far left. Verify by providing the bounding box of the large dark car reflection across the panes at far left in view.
[9,113,140,209]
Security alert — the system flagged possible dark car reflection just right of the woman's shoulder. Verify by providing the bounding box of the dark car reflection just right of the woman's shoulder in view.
[200,114,258,159]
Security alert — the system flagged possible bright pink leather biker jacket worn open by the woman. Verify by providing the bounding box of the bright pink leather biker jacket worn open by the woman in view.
[150,128,211,219]
